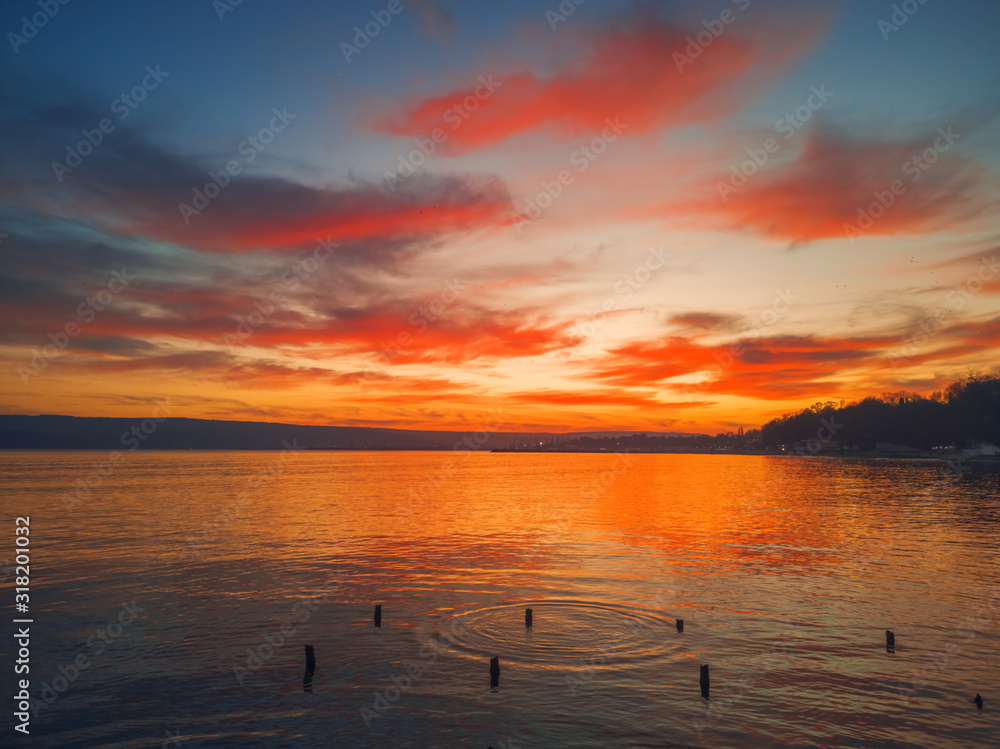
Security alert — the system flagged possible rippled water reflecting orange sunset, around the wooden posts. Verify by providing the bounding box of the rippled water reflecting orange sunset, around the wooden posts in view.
[0,451,1000,749]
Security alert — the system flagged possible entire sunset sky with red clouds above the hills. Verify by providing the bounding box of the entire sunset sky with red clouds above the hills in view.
[0,0,1000,433]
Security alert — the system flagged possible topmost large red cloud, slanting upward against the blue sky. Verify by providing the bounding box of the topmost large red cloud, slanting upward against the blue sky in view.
[369,10,819,154]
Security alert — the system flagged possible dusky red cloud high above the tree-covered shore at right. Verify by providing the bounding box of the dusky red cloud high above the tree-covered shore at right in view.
[664,128,984,242]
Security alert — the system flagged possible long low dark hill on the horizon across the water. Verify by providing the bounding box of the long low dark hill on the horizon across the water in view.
[0,415,704,450]
